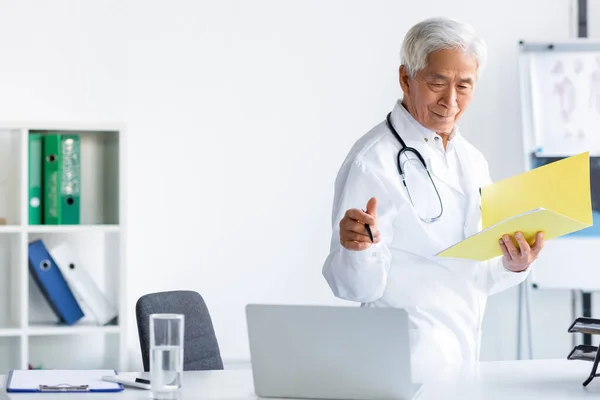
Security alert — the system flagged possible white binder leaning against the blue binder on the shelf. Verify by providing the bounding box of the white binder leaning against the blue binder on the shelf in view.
[48,242,118,325]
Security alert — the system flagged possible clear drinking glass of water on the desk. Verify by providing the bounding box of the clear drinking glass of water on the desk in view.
[150,314,185,400]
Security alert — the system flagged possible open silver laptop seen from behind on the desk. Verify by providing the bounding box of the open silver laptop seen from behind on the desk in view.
[246,304,421,400]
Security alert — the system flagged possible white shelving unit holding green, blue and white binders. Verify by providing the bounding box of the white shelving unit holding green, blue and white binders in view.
[0,122,128,374]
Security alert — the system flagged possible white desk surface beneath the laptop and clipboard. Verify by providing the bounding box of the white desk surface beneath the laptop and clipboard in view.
[0,360,600,400]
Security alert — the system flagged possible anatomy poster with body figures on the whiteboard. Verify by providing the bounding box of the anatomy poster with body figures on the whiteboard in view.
[531,51,600,157]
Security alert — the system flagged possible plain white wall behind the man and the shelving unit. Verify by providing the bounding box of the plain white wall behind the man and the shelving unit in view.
[0,0,584,368]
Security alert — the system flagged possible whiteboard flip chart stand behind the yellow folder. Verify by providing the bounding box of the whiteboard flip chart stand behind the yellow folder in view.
[519,38,600,291]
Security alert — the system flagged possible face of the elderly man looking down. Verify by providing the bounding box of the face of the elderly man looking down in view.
[400,50,477,134]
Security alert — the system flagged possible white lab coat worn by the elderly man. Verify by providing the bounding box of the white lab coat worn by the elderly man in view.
[323,100,529,381]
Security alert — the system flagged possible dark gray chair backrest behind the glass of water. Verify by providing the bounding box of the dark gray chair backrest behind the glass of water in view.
[135,290,223,372]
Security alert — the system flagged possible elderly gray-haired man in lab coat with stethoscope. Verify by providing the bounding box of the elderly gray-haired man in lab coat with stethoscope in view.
[323,18,543,379]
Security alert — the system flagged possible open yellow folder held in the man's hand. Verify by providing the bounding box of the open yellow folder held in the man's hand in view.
[438,152,593,261]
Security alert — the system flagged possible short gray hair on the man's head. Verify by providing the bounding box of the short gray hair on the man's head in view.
[400,18,487,78]
